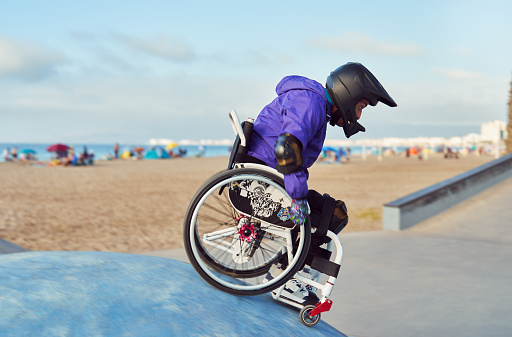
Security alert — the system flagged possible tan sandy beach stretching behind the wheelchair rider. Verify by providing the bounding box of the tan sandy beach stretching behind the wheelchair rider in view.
[0,155,494,252]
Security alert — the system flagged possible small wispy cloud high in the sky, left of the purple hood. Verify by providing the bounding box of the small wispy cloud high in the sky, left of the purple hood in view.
[116,35,195,62]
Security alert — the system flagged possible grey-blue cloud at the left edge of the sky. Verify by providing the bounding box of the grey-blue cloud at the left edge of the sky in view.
[0,35,66,80]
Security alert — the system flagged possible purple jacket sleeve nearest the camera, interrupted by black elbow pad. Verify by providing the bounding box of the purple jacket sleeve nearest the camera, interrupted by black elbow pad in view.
[280,90,325,199]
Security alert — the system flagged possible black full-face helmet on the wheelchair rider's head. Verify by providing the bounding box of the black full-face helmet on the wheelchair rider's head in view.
[326,62,396,138]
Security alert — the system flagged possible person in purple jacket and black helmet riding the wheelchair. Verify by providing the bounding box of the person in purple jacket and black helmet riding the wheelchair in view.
[247,63,397,305]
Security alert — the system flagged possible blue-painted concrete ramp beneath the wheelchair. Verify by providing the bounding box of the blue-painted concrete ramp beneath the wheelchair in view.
[0,252,345,337]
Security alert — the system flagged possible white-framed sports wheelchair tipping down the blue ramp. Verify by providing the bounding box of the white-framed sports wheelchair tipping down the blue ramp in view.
[183,110,343,326]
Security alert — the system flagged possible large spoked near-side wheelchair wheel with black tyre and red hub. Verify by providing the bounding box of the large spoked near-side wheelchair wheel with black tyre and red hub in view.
[184,168,311,295]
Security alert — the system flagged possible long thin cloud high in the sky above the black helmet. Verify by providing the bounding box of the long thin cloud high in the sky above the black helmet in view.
[306,32,424,56]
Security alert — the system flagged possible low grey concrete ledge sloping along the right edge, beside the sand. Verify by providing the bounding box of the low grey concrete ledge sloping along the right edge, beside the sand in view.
[382,153,512,230]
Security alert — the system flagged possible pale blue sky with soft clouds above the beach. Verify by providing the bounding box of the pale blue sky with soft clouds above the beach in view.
[0,0,512,144]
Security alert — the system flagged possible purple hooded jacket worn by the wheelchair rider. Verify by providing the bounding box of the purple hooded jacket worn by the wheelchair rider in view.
[248,76,332,199]
